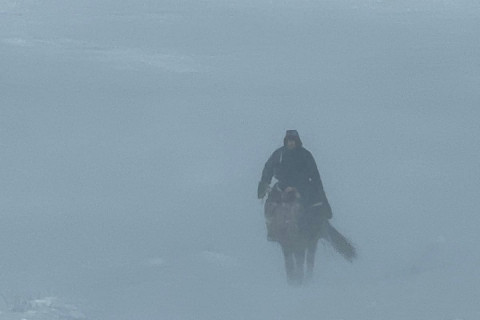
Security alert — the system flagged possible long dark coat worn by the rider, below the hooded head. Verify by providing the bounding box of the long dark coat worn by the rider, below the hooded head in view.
[261,144,331,216]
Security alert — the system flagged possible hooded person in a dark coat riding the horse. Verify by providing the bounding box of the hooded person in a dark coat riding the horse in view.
[258,130,332,220]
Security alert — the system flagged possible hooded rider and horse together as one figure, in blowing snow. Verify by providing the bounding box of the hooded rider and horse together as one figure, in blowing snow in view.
[257,130,357,285]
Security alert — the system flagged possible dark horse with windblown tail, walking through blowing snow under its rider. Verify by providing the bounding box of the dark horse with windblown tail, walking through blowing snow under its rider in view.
[265,185,356,285]
